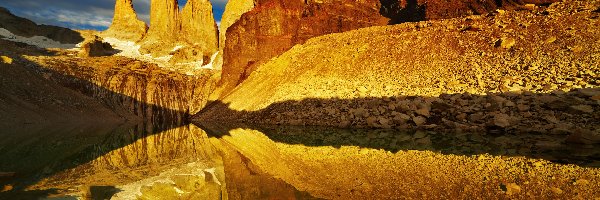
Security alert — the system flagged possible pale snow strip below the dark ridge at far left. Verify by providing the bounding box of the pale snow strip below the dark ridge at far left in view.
[0,28,76,49]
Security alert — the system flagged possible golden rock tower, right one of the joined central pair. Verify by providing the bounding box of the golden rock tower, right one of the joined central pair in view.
[181,0,218,56]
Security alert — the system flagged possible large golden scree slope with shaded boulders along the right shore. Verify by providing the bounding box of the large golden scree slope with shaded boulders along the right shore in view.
[198,0,600,138]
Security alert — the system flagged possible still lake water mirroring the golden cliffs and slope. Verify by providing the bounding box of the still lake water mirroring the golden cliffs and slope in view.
[0,124,600,199]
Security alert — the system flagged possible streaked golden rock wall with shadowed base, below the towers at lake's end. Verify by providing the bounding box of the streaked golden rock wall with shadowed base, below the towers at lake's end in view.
[37,57,216,125]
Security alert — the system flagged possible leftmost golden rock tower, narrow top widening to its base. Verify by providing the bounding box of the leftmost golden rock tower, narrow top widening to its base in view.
[102,0,148,41]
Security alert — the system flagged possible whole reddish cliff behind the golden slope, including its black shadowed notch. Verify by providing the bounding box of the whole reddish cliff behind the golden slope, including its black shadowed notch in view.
[217,0,554,97]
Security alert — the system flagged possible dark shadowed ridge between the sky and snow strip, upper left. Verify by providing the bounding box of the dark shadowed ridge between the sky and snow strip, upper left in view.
[0,7,83,44]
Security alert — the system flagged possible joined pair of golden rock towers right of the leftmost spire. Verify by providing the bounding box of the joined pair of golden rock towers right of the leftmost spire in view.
[140,0,219,62]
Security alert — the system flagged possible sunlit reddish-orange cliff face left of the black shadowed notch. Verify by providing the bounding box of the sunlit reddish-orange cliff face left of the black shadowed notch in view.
[221,0,388,97]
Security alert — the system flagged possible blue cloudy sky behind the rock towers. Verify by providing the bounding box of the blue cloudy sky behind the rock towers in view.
[0,0,227,30]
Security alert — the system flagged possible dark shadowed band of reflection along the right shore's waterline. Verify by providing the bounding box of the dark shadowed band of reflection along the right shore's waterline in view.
[197,123,600,168]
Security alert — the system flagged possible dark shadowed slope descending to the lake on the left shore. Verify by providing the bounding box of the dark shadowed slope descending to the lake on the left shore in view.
[0,40,129,129]
